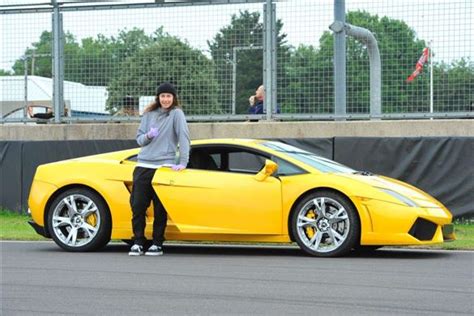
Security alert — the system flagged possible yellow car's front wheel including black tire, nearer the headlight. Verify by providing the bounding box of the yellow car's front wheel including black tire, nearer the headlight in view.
[291,190,360,257]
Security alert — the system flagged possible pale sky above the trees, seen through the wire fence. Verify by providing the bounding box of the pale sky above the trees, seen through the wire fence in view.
[0,0,474,70]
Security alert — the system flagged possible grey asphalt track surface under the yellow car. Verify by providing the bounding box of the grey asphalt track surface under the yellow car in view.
[0,242,474,315]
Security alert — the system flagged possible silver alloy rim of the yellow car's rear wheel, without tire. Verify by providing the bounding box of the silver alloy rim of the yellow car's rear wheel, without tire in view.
[52,194,101,247]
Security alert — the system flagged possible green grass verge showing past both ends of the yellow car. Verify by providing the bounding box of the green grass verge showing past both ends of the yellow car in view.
[0,210,474,250]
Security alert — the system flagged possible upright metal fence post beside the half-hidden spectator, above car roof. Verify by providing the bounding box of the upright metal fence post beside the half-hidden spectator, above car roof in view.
[263,0,277,120]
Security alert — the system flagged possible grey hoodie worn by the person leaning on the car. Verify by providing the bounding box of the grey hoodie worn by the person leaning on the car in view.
[137,108,190,166]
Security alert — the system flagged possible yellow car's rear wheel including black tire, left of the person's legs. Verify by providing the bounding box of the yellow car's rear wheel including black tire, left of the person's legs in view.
[47,188,112,252]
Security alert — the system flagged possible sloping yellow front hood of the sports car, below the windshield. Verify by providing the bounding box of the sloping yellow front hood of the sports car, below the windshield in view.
[341,174,443,208]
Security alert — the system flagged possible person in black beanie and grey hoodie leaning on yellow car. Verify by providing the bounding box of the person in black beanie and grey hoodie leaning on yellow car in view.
[128,83,190,256]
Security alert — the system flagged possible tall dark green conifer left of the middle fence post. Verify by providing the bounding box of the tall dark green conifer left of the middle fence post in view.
[208,10,288,113]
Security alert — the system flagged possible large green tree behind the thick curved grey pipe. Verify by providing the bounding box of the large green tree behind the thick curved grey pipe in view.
[282,11,429,113]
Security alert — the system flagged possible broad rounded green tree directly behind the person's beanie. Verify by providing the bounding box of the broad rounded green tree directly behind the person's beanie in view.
[107,34,221,115]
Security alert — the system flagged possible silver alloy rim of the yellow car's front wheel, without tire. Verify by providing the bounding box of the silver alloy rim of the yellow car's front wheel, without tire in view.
[296,197,350,252]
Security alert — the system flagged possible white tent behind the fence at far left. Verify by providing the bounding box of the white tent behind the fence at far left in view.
[0,76,108,118]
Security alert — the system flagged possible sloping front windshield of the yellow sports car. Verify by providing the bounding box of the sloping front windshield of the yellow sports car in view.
[262,141,356,173]
